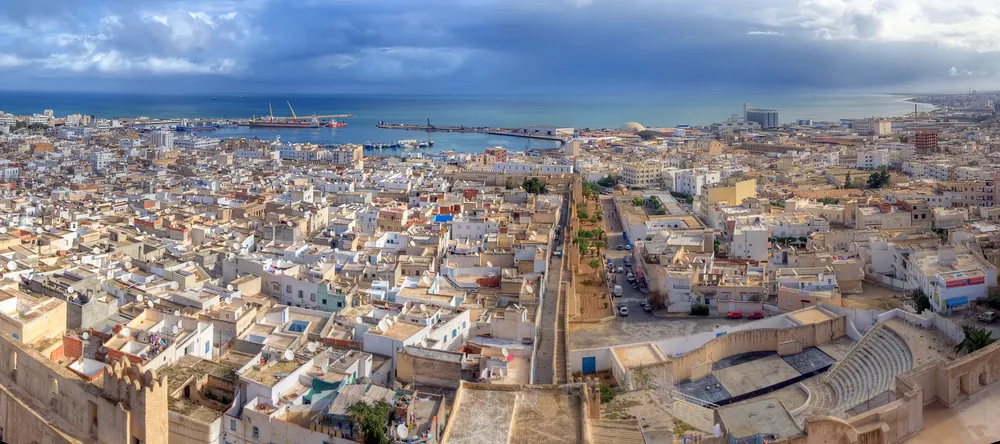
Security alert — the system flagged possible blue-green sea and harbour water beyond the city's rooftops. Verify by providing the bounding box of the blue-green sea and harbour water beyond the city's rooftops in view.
[0,91,933,154]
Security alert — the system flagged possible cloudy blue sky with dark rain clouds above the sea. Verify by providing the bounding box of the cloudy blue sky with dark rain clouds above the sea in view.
[0,0,1000,94]
